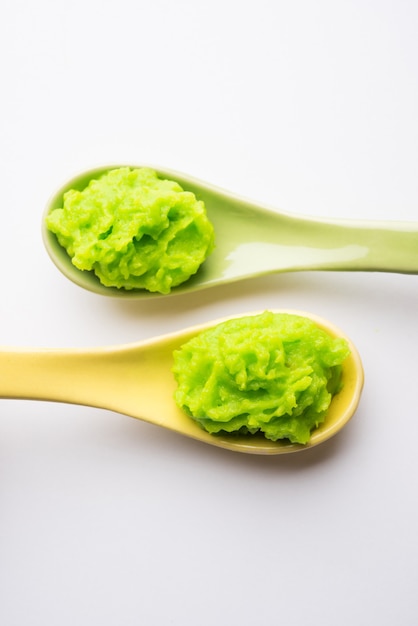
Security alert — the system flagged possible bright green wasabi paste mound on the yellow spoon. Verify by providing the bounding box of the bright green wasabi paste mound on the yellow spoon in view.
[173,311,350,444]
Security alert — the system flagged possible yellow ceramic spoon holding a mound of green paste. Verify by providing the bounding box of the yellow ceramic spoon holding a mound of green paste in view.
[0,311,363,455]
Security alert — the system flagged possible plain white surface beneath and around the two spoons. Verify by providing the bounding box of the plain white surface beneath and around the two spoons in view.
[0,0,418,626]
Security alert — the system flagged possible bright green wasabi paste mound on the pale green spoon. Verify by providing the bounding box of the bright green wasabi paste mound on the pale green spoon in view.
[46,167,214,293]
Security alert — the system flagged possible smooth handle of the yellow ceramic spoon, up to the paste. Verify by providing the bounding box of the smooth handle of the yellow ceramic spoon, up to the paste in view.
[0,339,177,424]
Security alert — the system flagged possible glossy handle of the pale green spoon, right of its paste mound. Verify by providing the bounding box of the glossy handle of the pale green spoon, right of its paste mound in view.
[175,176,418,272]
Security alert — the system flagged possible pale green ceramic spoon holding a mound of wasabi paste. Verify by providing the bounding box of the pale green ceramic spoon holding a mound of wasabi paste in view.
[43,165,418,298]
